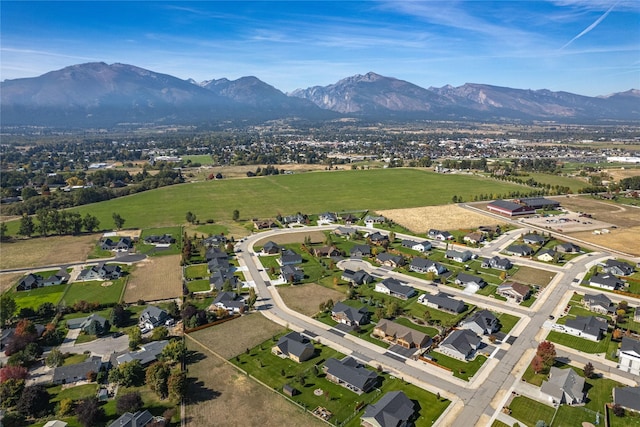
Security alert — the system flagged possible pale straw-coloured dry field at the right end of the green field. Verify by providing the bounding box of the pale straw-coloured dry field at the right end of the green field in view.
[378,205,504,233]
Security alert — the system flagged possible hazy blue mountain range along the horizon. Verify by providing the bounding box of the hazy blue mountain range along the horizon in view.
[0,63,640,128]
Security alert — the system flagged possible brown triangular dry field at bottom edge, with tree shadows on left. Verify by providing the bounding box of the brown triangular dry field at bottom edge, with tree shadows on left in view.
[185,338,326,427]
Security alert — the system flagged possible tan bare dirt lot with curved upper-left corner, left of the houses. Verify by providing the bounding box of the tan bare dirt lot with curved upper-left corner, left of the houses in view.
[124,255,182,302]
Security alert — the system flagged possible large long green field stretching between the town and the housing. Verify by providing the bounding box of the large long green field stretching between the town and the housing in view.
[38,169,523,234]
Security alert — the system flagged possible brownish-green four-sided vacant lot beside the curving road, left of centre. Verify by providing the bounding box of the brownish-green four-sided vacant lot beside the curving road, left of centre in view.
[190,313,284,359]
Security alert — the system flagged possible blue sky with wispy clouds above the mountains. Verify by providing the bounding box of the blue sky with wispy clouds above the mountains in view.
[0,0,640,95]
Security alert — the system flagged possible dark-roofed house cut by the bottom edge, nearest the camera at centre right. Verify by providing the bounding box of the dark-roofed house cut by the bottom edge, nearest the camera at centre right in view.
[360,391,416,427]
